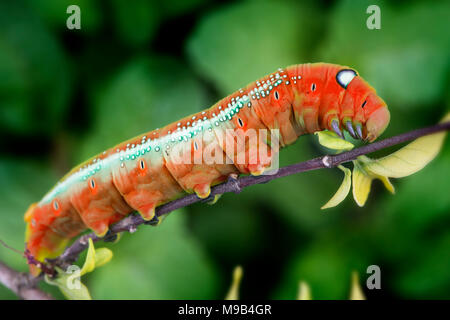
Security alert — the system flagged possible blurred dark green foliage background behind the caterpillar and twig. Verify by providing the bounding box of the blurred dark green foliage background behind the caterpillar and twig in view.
[0,0,450,299]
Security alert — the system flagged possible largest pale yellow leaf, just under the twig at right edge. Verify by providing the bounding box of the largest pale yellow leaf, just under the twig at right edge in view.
[360,113,450,178]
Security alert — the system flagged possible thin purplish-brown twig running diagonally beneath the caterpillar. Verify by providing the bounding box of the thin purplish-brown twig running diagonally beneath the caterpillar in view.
[0,122,450,299]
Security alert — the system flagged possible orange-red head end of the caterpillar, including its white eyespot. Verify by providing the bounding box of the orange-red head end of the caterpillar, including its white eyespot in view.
[336,69,390,142]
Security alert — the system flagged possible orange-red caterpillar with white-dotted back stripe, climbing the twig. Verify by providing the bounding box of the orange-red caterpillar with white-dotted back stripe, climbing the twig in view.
[25,63,390,275]
